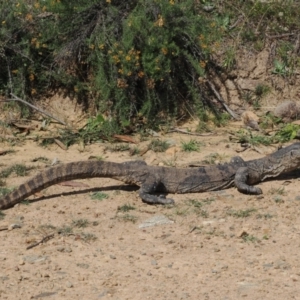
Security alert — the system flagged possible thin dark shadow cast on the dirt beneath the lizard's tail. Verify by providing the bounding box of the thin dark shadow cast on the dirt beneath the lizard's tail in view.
[30,185,139,203]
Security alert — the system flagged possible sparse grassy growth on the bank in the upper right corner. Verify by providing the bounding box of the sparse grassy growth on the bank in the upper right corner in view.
[216,0,300,77]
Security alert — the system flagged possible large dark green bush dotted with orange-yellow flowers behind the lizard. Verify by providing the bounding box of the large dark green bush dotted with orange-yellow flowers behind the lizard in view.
[0,0,223,128]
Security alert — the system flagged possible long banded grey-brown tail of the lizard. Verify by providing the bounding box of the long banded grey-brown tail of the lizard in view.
[0,161,129,209]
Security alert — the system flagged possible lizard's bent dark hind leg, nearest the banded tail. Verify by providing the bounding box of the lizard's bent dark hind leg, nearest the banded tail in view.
[139,176,175,205]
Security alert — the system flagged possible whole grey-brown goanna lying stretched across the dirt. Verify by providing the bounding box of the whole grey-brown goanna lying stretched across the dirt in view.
[0,143,300,209]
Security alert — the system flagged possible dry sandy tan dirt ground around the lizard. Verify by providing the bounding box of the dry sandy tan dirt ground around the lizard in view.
[0,127,300,300]
